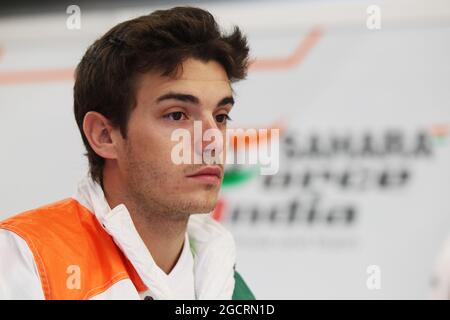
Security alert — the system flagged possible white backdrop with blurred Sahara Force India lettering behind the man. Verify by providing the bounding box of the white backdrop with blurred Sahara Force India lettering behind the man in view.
[0,1,450,299]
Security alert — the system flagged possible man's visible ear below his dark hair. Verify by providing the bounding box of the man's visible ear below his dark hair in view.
[83,111,117,159]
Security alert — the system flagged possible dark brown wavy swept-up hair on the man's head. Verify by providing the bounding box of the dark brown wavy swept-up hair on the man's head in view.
[74,7,249,183]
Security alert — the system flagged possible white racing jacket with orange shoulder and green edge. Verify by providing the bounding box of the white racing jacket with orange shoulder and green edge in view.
[0,177,254,299]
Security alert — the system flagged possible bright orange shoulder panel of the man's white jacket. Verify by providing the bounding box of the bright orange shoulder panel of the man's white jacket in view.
[0,199,147,299]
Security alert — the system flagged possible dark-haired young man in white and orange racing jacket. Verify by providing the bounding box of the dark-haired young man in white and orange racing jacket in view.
[0,7,254,299]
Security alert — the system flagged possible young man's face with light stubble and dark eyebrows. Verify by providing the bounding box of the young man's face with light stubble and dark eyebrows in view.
[117,59,232,215]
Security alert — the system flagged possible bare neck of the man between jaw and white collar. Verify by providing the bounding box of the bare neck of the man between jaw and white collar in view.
[103,171,189,274]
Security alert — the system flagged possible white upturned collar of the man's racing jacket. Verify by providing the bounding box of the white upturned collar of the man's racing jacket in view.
[74,174,236,300]
